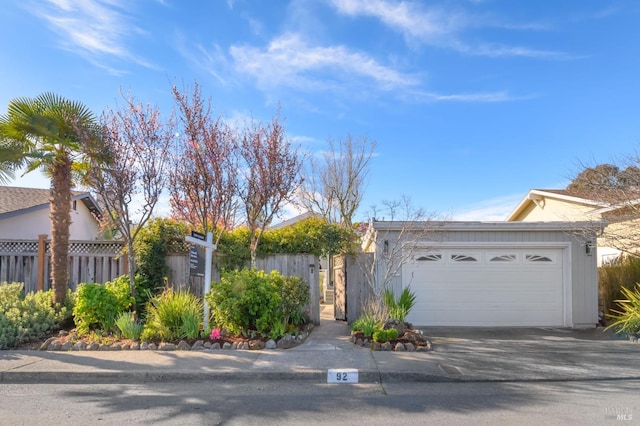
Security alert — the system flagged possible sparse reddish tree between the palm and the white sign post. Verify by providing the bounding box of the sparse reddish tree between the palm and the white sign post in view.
[89,97,174,304]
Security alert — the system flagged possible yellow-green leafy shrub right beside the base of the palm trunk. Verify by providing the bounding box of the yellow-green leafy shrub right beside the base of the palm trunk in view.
[73,277,133,335]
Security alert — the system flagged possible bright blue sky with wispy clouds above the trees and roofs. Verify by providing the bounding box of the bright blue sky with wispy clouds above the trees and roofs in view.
[0,0,640,220]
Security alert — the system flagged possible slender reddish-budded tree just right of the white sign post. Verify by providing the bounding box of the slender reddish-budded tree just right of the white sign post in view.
[239,111,302,267]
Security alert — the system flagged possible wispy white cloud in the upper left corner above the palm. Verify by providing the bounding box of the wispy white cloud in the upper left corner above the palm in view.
[32,0,155,74]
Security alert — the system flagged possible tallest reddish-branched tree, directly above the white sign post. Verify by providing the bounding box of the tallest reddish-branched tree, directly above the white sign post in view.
[169,83,238,244]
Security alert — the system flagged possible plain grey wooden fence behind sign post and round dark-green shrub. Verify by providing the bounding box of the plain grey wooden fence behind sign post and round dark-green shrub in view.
[166,253,320,324]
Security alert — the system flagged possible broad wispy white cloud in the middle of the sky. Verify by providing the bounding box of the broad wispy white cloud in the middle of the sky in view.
[230,33,419,91]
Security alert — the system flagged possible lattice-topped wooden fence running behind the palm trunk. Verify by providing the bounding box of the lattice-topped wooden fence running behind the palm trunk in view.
[0,236,127,292]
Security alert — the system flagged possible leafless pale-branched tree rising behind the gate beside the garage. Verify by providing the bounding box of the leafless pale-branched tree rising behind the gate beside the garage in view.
[301,135,376,228]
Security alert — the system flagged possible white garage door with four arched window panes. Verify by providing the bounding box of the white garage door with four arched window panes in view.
[402,248,564,326]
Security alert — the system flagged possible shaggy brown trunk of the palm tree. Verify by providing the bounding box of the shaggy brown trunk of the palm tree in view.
[49,155,71,303]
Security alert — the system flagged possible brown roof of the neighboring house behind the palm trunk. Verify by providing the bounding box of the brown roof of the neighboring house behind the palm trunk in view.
[0,186,101,219]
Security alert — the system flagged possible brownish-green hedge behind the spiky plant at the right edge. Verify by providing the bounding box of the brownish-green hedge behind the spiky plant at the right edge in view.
[598,255,640,314]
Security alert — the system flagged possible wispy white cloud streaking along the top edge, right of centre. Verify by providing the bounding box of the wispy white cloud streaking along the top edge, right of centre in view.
[330,0,571,59]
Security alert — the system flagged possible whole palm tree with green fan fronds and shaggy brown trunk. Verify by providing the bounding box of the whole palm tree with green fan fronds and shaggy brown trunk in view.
[0,93,101,303]
